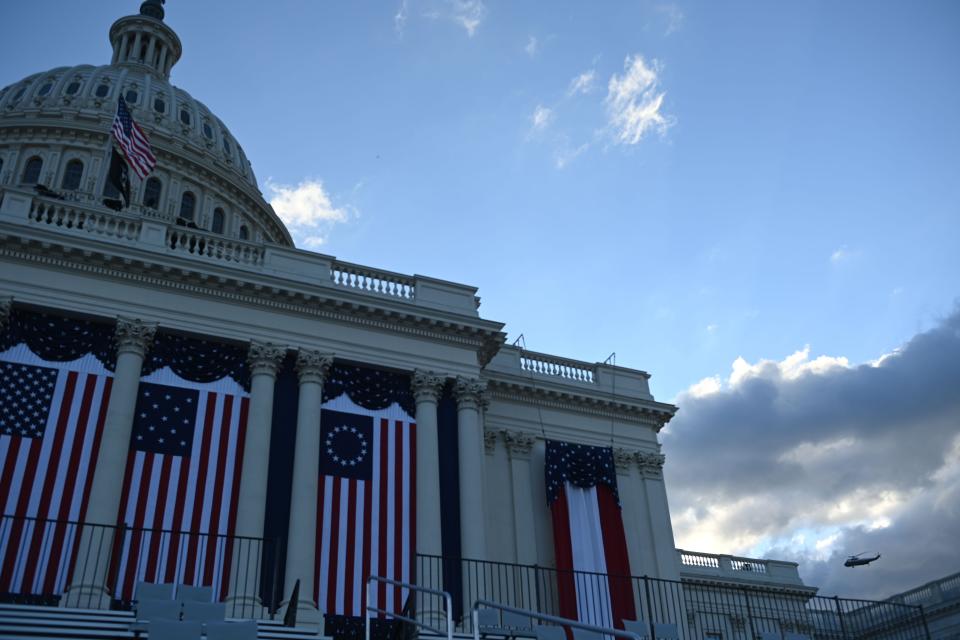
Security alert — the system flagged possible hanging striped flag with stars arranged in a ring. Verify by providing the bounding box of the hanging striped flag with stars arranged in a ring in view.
[315,393,416,616]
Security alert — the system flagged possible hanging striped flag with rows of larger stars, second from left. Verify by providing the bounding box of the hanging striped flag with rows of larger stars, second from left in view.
[115,367,249,600]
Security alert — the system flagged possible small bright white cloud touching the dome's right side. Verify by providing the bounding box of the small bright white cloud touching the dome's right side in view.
[267,179,355,249]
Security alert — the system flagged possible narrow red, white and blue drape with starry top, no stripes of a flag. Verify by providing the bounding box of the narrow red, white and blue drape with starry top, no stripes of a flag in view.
[546,440,637,629]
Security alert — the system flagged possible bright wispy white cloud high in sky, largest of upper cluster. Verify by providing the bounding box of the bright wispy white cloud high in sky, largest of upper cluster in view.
[605,54,673,145]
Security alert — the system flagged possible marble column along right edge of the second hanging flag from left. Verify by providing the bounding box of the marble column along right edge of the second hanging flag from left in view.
[227,342,287,615]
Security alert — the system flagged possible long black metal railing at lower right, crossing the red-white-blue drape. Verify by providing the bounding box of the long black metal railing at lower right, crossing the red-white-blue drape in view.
[416,555,929,640]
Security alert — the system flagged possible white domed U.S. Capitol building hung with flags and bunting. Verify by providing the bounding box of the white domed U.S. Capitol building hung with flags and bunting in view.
[0,0,932,640]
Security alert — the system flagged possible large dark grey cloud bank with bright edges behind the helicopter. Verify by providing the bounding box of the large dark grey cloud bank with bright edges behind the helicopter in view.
[663,311,960,596]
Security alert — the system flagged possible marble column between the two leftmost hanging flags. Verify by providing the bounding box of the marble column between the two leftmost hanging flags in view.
[61,318,157,607]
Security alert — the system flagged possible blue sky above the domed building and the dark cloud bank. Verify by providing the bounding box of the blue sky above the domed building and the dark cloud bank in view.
[0,0,960,588]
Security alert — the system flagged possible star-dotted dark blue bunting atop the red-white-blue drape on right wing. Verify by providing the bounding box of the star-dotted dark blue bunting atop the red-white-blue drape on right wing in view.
[546,440,620,505]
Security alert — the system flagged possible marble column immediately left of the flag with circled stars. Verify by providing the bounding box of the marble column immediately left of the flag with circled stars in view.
[283,349,333,624]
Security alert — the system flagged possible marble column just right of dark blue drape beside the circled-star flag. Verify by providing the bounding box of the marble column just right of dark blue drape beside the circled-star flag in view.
[454,377,487,560]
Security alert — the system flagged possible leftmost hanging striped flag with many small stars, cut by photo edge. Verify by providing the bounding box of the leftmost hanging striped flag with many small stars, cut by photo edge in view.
[0,343,113,596]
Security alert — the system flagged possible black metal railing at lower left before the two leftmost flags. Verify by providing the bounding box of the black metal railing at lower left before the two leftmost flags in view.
[0,515,281,618]
